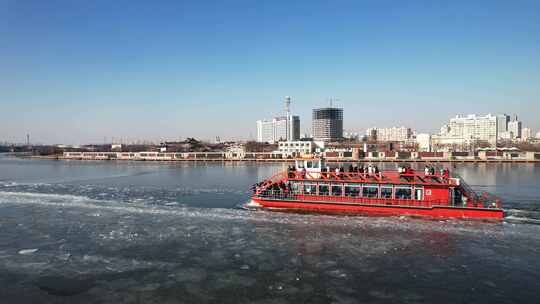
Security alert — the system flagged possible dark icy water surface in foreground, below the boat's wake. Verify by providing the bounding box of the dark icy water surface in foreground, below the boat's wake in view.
[0,192,540,303]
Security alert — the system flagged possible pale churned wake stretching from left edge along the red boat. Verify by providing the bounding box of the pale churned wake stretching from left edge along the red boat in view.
[0,191,510,233]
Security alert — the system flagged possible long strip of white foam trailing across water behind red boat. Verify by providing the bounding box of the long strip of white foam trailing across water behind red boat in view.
[0,191,516,233]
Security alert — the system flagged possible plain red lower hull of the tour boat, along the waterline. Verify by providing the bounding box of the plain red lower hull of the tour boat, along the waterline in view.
[252,197,504,219]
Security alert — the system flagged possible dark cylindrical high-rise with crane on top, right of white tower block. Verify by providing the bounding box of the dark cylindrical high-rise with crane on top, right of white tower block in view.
[312,107,343,141]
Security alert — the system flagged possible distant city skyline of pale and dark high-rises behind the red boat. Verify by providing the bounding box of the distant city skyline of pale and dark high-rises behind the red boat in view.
[253,97,540,155]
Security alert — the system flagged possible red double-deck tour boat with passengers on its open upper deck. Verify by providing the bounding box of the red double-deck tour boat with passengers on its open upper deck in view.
[246,158,504,218]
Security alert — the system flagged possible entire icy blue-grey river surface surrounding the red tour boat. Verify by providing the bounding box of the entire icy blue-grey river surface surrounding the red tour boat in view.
[0,156,540,303]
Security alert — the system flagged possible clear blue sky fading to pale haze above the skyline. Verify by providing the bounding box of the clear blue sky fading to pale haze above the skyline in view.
[0,0,540,143]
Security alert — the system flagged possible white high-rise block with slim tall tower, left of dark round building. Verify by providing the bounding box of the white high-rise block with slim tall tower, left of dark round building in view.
[257,96,300,143]
